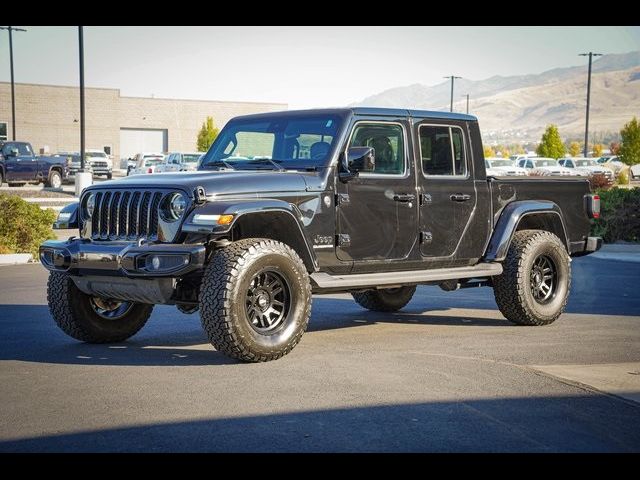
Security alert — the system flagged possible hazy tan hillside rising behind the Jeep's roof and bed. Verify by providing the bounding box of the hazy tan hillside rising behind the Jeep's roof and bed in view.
[356,51,640,141]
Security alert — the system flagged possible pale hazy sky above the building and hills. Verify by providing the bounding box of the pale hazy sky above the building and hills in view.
[0,26,640,108]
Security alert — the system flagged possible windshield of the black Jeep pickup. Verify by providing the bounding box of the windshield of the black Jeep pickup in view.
[200,115,341,170]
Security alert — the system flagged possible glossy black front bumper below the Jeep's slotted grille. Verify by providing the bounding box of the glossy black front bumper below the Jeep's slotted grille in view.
[40,238,206,278]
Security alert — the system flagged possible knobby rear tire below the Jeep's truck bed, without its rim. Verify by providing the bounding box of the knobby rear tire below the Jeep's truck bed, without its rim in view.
[493,230,571,326]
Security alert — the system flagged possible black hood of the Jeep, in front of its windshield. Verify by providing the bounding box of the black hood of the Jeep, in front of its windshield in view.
[95,170,317,196]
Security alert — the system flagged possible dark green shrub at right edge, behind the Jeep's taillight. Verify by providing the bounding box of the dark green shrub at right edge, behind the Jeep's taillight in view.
[591,187,640,243]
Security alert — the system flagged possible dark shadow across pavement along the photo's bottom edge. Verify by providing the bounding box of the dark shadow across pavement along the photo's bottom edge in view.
[0,394,640,452]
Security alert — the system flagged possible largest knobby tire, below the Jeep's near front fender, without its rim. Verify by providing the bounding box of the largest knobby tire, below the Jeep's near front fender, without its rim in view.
[200,238,311,362]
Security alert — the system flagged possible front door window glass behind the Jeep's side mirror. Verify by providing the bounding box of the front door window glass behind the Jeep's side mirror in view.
[349,123,405,175]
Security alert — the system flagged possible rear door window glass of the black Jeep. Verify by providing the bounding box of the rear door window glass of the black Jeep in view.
[420,125,467,176]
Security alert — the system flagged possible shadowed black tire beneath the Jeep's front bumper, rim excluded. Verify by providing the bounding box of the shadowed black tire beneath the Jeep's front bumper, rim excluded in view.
[47,272,153,343]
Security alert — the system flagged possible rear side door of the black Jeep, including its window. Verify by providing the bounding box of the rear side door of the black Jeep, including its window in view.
[415,121,484,260]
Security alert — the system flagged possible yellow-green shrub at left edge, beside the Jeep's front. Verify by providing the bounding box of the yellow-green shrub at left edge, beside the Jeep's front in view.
[0,193,56,258]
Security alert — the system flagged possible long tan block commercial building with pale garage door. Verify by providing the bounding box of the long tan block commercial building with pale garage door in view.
[0,82,287,166]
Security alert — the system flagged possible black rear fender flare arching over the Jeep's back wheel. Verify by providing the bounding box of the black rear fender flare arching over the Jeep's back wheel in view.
[484,200,569,262]
